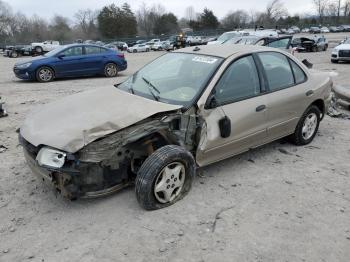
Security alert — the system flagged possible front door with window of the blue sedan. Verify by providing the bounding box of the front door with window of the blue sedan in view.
[54,46,85,76]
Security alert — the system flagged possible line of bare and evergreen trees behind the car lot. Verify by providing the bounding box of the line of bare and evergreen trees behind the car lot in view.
[0,0,350,43]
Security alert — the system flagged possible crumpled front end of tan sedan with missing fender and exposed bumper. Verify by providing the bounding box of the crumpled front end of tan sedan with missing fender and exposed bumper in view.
[19,111,197,199]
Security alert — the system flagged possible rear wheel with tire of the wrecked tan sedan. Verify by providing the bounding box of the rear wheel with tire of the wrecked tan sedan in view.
[290,105,321,146]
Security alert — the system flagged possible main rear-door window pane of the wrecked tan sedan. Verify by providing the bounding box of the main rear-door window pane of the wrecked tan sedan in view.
[258,52,294,91]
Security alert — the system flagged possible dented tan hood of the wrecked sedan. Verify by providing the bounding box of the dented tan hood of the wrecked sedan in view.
[21,86,181,153]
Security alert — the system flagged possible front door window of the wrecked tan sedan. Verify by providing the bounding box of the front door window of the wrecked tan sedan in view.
[215,56,260,104]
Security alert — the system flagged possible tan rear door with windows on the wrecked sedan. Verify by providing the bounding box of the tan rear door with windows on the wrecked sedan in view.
[258,52,312,141]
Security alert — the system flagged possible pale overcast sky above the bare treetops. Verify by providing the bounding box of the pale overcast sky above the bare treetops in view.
[4,0,314,18]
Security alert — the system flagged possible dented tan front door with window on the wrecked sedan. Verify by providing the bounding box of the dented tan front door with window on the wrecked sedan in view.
[196,55,267,166]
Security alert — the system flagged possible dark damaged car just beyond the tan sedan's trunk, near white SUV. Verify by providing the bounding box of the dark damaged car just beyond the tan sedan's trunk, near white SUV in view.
[291,35,328,52]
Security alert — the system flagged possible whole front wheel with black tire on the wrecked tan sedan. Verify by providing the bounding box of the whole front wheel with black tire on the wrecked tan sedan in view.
[135,145,196,210]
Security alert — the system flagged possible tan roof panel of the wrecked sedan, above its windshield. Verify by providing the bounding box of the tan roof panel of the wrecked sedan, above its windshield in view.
[173,44,279,58]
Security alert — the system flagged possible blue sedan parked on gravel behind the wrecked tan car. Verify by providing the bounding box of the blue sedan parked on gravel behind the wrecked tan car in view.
[13,44,127,82]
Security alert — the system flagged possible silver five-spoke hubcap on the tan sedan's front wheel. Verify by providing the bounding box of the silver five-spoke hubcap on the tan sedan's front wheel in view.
[154,162,186,204]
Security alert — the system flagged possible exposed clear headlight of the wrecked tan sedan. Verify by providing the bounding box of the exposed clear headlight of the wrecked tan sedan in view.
[36,147,67,168]
